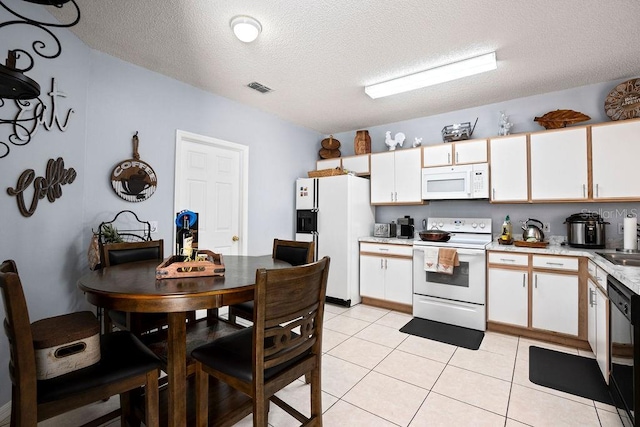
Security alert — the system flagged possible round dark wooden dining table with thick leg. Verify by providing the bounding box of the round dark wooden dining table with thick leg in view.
[78,255,290,426]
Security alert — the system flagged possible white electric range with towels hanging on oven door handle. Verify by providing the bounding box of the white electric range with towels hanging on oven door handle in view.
[413,218,492,331]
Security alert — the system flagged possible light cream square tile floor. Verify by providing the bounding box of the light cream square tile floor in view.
[0,305,622,427]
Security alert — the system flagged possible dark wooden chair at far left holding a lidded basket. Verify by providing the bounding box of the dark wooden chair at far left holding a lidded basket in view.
[0,260,160,427]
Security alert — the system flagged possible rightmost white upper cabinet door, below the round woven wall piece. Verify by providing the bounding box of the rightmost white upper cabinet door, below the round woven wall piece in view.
[591,120,640,199]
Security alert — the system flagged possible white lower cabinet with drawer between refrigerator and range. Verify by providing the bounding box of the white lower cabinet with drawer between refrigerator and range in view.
[360,243,413,305]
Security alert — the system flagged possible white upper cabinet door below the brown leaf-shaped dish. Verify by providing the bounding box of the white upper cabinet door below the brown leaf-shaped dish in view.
[529,127,588,201]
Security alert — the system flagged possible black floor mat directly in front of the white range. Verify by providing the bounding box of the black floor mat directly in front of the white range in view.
[400,317,484,350]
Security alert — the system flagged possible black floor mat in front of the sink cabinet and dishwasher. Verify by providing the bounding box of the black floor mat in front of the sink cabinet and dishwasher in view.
[529,346,613,405]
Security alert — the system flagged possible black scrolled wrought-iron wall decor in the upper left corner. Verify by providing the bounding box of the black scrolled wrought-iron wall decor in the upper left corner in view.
[0,0,80,158]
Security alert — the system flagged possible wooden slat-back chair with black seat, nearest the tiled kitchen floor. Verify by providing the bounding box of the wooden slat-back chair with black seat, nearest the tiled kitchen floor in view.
[191,257,330,427]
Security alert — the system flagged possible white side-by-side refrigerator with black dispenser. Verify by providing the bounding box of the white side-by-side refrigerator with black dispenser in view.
[296,175,375,307]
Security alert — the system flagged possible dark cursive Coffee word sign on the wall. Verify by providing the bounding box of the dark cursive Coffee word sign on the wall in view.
[7,157,77,217]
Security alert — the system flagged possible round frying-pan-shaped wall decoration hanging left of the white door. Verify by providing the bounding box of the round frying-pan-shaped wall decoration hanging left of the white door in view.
[111,132,158,202]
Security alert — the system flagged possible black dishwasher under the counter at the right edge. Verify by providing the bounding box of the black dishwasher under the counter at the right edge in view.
[607,275,640,427]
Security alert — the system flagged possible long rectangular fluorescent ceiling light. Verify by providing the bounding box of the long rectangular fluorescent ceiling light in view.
[364,52,497,99]
